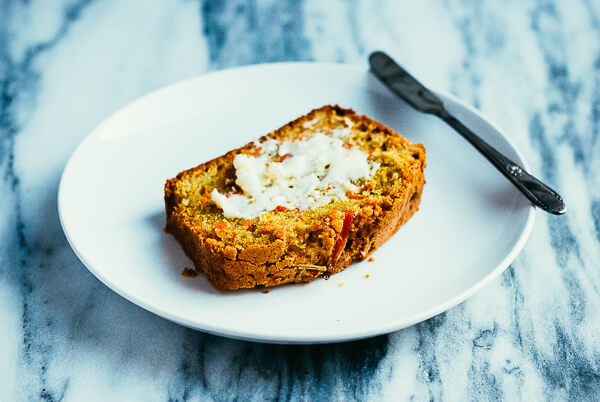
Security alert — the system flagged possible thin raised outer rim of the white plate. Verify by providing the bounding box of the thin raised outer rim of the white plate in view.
[57,62,536,344]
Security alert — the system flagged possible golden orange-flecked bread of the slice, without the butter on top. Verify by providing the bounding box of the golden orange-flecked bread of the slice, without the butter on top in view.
[165,106,425,290]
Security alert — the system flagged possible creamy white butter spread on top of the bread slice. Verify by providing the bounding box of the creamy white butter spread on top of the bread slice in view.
[211,127,379,219]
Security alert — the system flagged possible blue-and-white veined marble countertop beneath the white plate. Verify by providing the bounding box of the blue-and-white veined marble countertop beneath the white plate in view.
[0,0,600,401]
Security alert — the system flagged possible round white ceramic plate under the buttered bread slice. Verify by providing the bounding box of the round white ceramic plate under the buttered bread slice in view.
[58,63,534,343]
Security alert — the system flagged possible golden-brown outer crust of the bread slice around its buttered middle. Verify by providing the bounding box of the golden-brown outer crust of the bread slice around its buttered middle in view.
[165,105,426,290]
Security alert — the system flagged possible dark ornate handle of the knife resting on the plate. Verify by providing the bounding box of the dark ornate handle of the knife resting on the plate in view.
[436,109,567,215]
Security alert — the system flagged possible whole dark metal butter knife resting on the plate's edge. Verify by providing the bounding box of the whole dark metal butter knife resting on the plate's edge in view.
[369,51,567,215]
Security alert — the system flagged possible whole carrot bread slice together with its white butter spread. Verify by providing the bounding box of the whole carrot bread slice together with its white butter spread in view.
[165,106,425,290]
